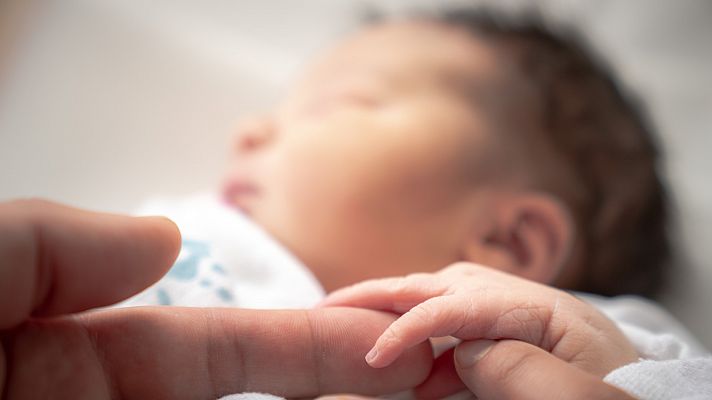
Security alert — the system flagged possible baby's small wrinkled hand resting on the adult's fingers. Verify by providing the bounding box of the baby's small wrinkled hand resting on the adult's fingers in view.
[320,263,638,377]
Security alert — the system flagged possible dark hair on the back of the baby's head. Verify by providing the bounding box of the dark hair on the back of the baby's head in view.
[369,7,670,297]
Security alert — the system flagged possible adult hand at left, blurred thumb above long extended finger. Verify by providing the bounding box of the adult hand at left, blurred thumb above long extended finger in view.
[0,200,432,399]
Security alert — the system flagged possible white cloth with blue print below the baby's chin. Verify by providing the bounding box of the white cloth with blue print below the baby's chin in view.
[120,195,324,309]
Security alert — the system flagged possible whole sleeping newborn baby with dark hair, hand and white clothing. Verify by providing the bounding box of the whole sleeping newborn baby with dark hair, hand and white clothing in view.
[123,9,704,398]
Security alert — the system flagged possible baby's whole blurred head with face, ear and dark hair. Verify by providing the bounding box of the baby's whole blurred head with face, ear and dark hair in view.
[225,8,667,295]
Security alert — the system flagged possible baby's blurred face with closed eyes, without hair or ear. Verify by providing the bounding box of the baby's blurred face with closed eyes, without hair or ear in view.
[225,23,504,291]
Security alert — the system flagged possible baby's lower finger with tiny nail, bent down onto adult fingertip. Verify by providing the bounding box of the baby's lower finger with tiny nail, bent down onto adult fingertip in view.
[366,296,469,368]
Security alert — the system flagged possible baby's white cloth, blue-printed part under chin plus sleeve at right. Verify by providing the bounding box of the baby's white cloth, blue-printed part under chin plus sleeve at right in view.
[120,195,712,400]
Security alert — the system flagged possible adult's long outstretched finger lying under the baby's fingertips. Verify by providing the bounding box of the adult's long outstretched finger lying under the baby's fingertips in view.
[6,307,432,400]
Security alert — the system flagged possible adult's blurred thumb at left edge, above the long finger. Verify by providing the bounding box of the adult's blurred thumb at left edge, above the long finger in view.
[0,200,180,329]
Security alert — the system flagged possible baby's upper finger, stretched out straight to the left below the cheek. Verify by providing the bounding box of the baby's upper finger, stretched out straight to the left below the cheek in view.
[319,273,447,314]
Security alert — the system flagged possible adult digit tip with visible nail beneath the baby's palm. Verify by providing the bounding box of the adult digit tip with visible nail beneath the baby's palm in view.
[455,340,633,400]
